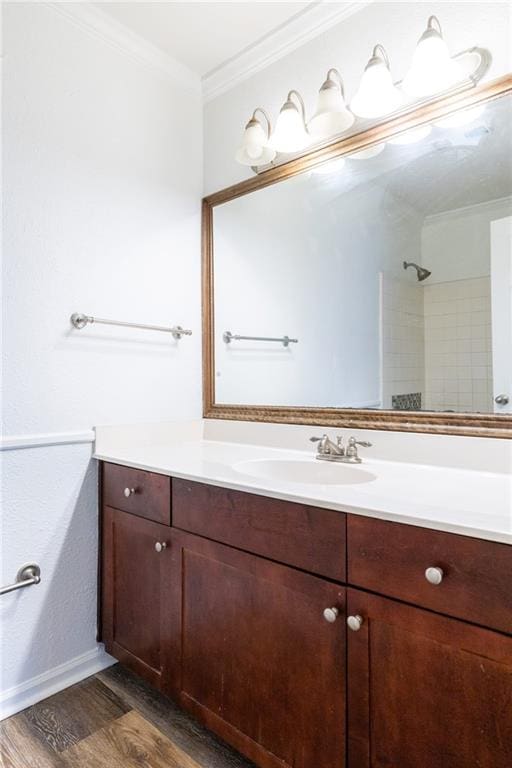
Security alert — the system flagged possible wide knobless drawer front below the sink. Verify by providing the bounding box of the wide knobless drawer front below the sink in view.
[172,479,346,581]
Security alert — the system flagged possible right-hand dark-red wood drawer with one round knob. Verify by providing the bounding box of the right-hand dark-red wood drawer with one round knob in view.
[347,515,512,634]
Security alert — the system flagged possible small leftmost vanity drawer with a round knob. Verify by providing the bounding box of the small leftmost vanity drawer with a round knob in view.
[103,464,171,525]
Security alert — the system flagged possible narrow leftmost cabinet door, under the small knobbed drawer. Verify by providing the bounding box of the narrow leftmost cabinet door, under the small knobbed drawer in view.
[102,507,172,689]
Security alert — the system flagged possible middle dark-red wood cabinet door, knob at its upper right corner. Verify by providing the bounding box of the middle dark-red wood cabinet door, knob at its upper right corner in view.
[177,534,346,768]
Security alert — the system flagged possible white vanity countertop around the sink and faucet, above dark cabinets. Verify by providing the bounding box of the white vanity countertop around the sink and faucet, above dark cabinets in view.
[94,422,512,544]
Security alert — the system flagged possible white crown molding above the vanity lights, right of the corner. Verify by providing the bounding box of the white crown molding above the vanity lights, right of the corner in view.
[201,0,375,102]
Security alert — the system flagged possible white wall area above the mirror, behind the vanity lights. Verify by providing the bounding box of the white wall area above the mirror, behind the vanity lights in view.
[204,0,512,193]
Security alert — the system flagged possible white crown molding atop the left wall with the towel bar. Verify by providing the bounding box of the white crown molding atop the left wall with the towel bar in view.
[41,2,201,92]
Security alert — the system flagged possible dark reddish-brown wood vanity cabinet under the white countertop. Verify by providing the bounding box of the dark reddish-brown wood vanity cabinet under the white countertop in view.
[97,444,512,768]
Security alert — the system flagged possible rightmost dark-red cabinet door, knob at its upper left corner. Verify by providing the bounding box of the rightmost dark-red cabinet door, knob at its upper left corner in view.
[347,589,512,768]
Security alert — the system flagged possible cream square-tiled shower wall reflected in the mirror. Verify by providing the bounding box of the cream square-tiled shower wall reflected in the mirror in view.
[381,273,493,413]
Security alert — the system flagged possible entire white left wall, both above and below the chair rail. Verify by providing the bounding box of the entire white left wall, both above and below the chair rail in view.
[0,3,202,716]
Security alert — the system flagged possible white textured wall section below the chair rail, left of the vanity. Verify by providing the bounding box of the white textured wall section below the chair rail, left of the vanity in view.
[0,445,98,690]
